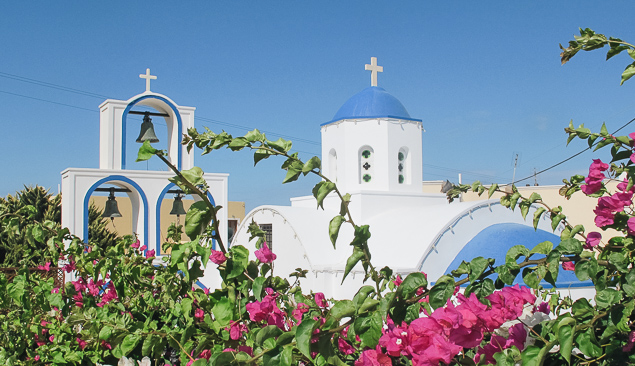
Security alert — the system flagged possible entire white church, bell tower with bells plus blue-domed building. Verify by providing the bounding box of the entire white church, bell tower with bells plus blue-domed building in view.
[61,61,589,298]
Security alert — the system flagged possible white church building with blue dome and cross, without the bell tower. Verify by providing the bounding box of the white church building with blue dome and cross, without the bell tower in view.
[232,57,589,298]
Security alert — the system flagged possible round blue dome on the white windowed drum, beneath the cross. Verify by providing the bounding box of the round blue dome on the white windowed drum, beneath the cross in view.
[324,86,421,124]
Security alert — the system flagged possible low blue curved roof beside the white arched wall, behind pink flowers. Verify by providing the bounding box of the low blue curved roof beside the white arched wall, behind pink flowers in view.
[445,223,593,288]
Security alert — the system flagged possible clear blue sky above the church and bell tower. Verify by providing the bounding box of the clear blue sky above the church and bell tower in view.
[0,0,635,209]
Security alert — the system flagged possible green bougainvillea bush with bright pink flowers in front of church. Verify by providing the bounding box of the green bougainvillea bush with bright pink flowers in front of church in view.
[0,30,635,366]
